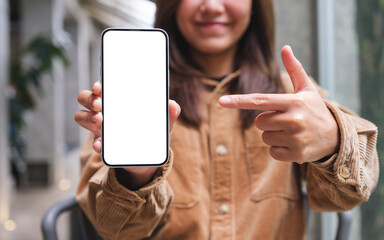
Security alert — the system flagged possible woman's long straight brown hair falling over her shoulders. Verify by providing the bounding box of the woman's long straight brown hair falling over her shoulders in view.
[155,0,280,128]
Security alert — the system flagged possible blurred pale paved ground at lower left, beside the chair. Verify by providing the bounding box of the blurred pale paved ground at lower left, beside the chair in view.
[0,149,80,240]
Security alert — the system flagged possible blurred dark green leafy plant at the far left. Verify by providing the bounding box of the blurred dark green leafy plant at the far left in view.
[6,35,69,187]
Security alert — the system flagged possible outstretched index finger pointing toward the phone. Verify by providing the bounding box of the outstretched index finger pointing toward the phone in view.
[219,93,291,112]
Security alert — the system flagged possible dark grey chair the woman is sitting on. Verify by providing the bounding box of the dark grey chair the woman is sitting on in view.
[41,195,353,240]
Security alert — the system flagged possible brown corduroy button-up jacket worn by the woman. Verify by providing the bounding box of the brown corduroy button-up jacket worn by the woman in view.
[77,72,379,240]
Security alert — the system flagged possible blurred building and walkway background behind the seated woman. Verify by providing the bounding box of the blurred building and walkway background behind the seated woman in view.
[0,0,384,240]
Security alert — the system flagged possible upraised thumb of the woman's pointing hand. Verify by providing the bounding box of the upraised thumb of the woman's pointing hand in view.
[281,45,316,93]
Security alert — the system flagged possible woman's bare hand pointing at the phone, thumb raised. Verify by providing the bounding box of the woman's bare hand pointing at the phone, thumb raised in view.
[219,46,340,163]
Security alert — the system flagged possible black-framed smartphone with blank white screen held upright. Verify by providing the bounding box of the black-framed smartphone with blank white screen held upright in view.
[101,28,169,167]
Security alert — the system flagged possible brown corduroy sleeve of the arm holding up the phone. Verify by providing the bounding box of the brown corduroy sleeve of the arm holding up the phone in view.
[76,134,173,239]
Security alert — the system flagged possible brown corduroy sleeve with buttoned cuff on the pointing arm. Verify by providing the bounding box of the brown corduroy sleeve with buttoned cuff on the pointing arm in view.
[302,101,379,211]
